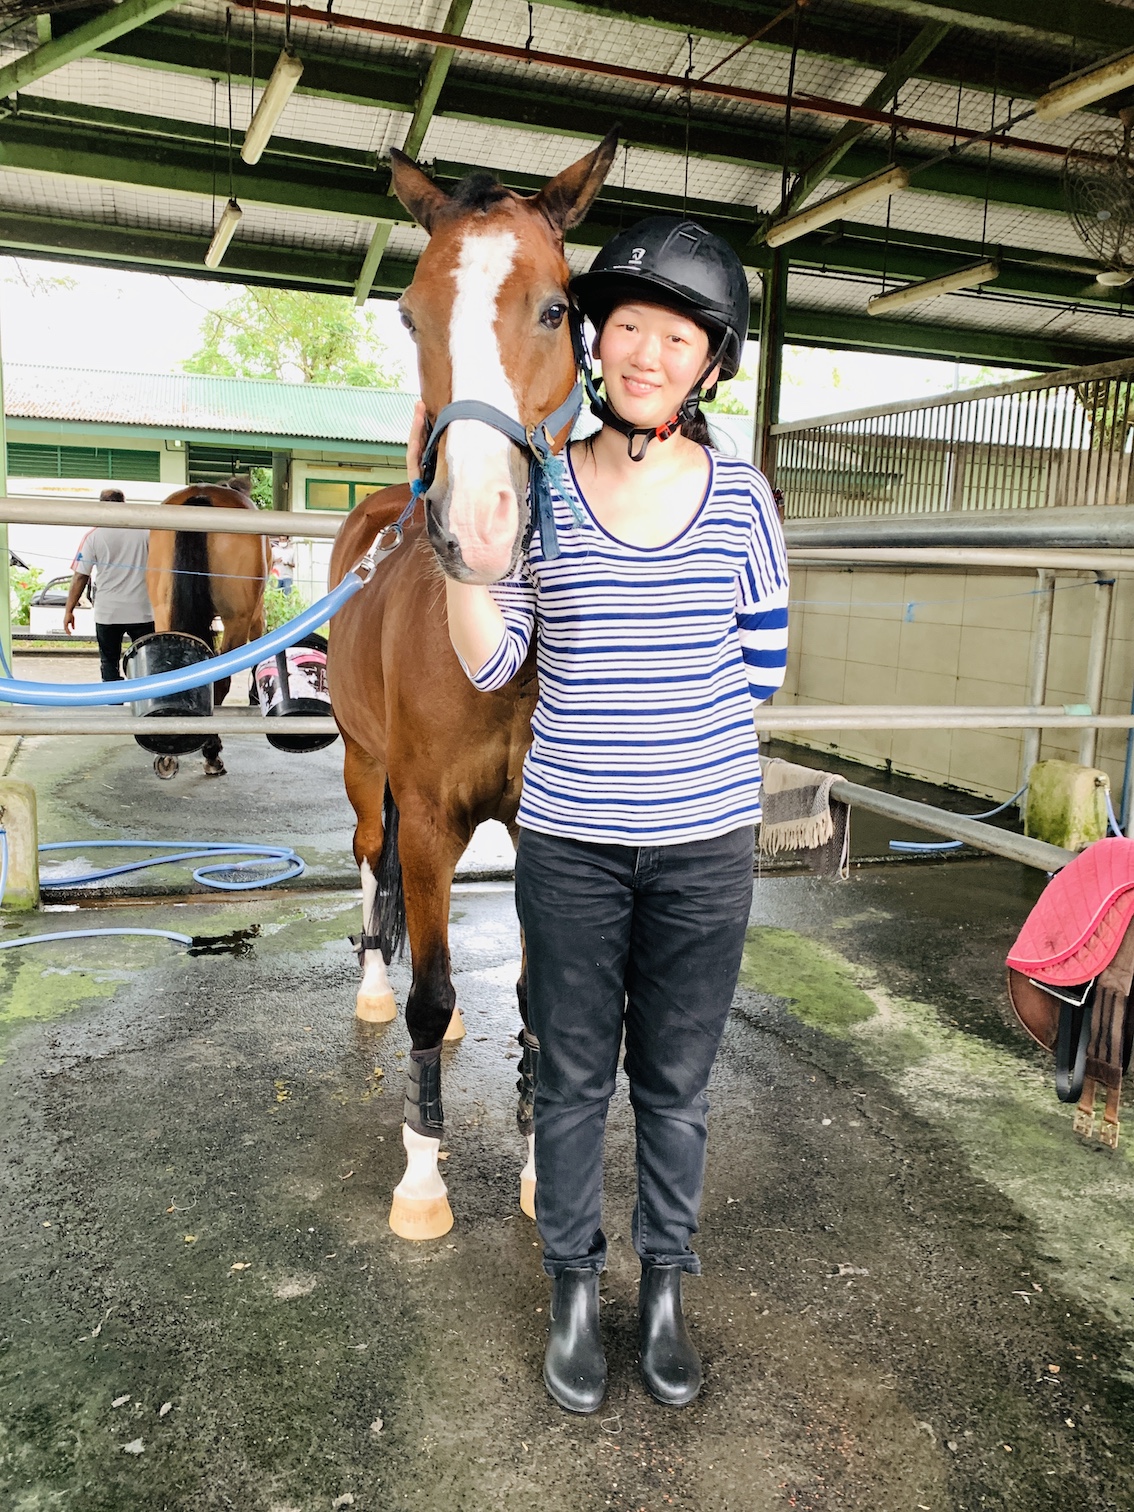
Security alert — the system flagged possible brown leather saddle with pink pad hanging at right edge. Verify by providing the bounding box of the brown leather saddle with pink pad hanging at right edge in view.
[1007,838,1134,1149]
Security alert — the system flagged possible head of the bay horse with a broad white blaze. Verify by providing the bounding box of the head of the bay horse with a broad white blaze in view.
[390,133,617,582]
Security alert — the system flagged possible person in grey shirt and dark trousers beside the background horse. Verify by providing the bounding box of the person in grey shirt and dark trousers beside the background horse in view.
[64,488,154,682]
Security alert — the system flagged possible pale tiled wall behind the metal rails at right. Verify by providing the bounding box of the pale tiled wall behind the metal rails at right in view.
[776,567,1134,798]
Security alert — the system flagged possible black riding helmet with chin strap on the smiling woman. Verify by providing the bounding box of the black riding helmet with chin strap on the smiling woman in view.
[570,215,748,461]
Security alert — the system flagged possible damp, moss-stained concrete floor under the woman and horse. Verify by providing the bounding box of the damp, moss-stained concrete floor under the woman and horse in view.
[0,710,1134,1512]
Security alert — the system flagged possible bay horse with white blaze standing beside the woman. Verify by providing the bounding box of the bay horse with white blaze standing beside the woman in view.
[328,133,617,1238]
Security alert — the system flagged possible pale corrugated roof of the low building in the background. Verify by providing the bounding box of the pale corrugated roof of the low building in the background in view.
[5,363,416,445]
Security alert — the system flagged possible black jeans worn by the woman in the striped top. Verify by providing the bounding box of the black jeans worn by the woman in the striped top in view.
[516,826,753,1276]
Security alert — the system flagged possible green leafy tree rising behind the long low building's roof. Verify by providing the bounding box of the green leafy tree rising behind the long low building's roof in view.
[183,289,405,389]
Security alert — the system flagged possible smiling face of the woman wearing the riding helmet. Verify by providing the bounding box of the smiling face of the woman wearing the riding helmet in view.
[596,304,714,426]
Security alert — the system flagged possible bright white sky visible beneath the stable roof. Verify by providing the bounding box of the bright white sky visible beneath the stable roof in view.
[0,257,1019,420]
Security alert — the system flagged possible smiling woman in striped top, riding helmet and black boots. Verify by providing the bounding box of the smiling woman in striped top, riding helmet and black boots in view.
[446,216,788,1412]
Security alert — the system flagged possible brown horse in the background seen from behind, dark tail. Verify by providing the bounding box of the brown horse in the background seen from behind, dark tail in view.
[145,478,269,777]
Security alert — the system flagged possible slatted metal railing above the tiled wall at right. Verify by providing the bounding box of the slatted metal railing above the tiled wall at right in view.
[773,358,1134,520]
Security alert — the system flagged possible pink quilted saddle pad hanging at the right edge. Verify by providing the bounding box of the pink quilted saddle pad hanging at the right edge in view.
[1009,838,1134,987]
